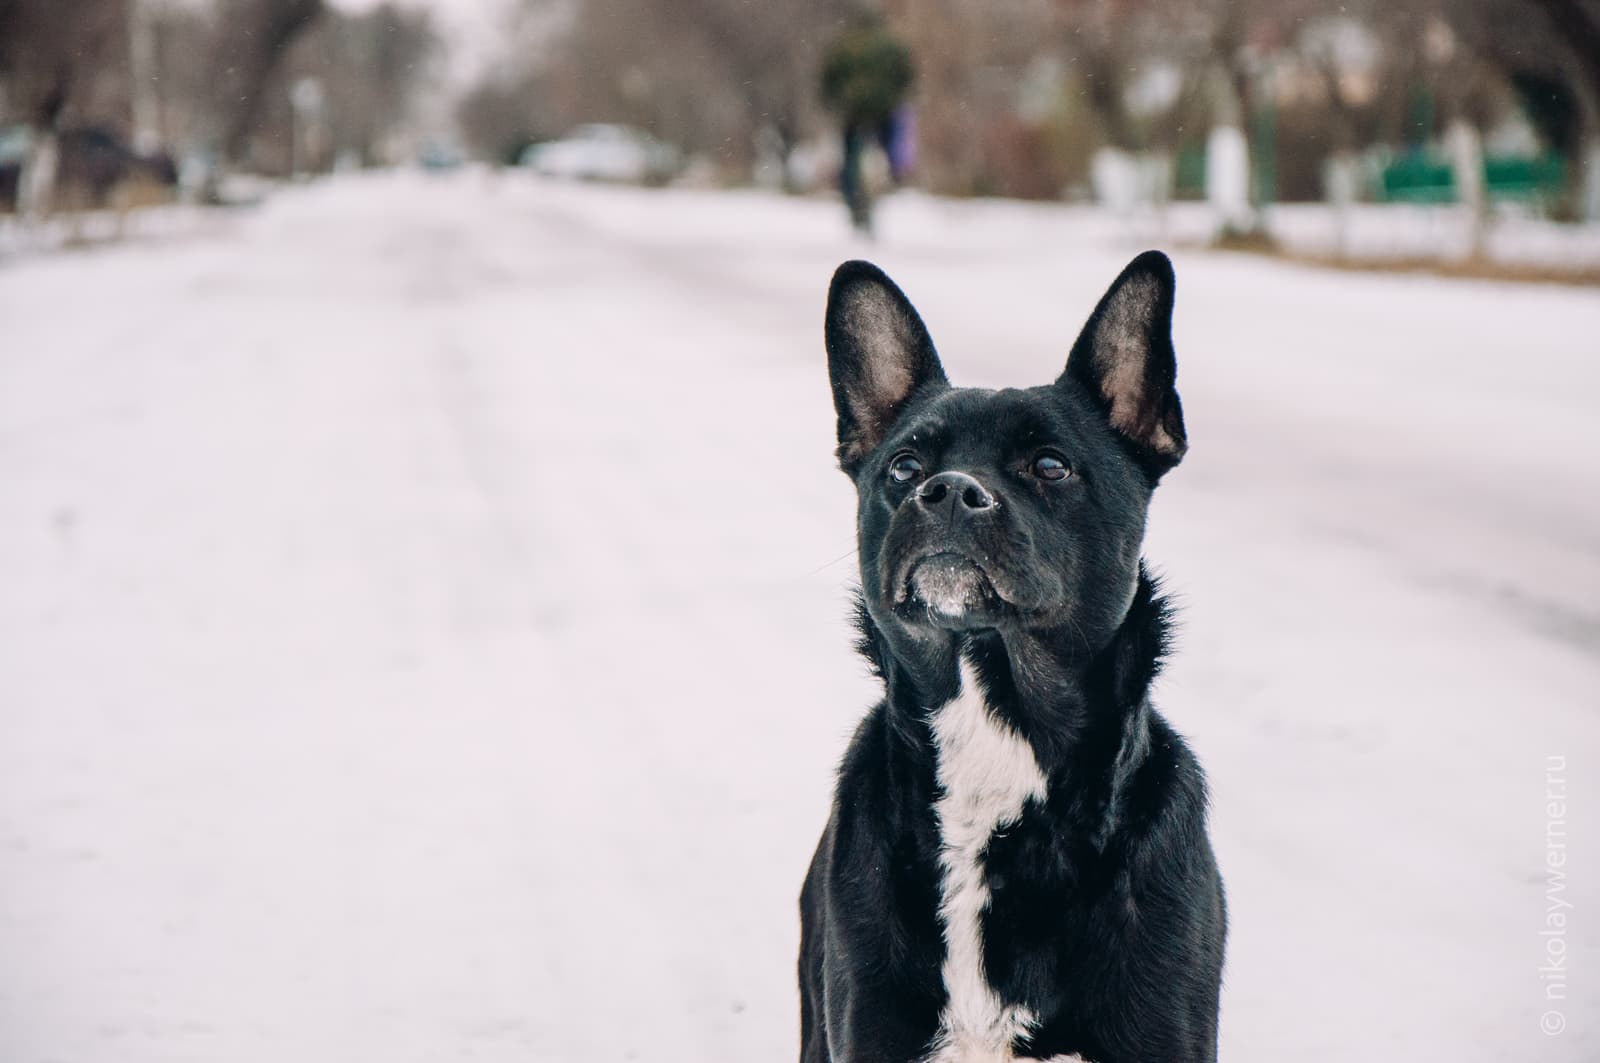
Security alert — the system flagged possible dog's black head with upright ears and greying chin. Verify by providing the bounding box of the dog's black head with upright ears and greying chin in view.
[827,251,1187,645]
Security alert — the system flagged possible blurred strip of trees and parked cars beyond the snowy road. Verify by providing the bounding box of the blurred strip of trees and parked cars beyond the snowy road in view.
[0,0,1600,257]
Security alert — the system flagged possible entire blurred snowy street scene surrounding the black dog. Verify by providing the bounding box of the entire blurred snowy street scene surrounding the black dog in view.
[0,0,1600,1063]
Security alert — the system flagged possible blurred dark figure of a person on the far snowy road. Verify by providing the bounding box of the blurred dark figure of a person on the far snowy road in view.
[822,16,915,234]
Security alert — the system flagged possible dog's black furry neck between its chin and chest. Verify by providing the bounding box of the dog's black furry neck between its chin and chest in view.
[861,568,1171,828]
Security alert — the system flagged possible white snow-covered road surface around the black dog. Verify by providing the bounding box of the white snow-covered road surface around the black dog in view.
[0,174,1600,1063]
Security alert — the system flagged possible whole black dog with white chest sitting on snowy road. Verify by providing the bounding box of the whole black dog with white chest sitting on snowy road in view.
[800,251,1226,1063]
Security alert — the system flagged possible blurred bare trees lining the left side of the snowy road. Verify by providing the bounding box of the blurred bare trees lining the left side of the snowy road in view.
[0,0,438,214]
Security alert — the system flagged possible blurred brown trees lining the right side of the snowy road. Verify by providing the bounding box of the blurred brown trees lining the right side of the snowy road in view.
[461,0,1600,213]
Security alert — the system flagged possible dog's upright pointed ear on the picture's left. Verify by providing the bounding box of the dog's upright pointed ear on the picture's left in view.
[824,261,949,475]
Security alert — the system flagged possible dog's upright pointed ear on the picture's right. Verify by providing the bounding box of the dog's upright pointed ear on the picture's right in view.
[1058,251,1189,480]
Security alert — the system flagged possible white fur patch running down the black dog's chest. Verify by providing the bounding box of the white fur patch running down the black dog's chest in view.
[926,660,1075,1063]
